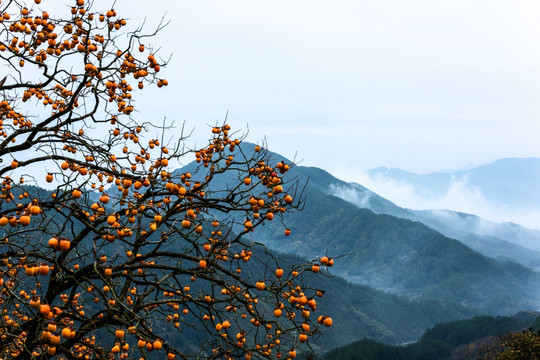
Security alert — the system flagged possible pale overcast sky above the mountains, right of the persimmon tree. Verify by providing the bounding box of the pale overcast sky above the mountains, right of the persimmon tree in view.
[39,0,540,228]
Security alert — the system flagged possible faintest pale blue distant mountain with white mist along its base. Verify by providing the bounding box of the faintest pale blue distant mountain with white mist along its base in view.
[360,157,540,228]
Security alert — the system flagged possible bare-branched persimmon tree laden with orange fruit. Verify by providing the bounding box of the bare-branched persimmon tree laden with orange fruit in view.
[0,0,332,360]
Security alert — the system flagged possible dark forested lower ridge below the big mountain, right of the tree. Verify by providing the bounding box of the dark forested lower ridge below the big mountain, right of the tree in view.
[251,252,479,349]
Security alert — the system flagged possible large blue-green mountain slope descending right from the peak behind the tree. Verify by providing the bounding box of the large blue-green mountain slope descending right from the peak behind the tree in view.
[174,144,540,314]
